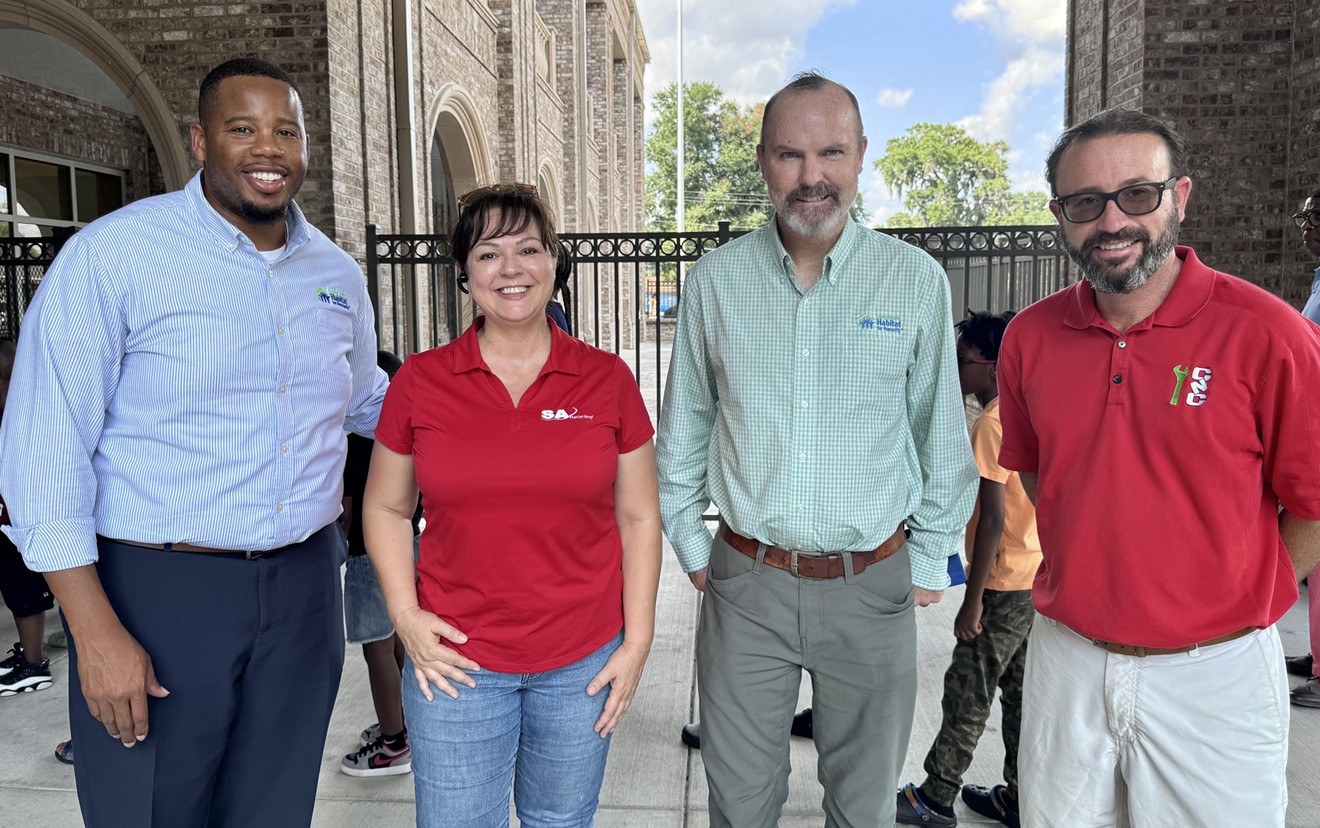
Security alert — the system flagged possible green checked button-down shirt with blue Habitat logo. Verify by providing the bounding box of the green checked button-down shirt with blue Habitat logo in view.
[657,219,978,589]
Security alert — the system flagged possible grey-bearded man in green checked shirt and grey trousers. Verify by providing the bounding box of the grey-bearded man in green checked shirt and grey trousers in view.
[657,74,978,828]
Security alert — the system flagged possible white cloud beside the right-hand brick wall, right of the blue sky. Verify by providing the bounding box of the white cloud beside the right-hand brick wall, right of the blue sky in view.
[953,0,1067,140]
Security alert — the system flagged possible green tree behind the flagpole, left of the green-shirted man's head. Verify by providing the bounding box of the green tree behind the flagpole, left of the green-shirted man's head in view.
[647,82,771,232]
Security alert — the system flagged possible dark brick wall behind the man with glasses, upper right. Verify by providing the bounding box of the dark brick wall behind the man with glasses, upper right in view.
[1067,0,1320,305]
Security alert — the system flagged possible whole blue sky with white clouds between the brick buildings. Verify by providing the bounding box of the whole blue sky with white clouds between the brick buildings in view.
[635,0,1064,224]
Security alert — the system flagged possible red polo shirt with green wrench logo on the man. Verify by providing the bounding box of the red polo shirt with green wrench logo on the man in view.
[999,247,1320,647]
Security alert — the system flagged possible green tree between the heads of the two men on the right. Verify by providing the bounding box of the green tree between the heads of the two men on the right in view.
[875,123,1053,227]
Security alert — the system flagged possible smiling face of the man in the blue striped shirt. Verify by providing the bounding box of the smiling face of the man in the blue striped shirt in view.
[189,75,308,250]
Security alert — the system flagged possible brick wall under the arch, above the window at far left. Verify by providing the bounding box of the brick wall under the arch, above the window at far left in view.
[0,75,160,201]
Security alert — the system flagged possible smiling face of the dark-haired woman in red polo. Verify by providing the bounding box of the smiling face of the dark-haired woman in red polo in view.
[463,213,554,334]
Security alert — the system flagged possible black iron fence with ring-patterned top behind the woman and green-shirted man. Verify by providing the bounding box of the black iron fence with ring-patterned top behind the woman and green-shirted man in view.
[367,222,1071,419]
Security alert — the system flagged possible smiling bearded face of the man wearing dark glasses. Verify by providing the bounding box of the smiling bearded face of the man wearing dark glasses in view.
[1049,132,1192,293]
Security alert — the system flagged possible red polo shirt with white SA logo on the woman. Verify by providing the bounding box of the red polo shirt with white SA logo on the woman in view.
[376,320,655,672]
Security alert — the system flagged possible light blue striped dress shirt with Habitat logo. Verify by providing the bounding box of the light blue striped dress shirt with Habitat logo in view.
[0,173,388,572]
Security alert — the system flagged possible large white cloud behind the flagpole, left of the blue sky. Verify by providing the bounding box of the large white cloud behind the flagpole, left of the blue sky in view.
[636,0,857,125]
